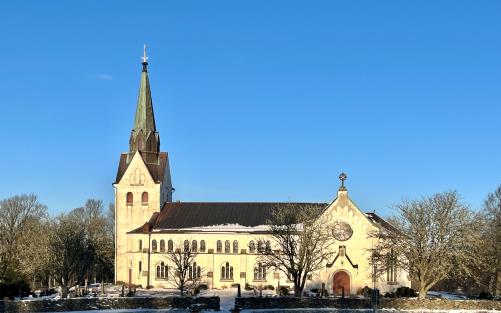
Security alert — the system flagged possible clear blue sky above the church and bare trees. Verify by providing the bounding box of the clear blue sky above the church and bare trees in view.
[0,0,501,215]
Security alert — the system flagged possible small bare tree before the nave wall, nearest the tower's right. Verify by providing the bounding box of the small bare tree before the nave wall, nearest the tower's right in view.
[166,240,203,296]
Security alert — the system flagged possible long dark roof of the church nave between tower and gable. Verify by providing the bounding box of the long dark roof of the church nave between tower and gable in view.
[127,202,328,233]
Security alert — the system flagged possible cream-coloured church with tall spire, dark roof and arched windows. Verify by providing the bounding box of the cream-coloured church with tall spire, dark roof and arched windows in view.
[113,51,410,295]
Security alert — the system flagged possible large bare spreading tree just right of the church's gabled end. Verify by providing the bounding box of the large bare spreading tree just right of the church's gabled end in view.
[370,191,475,298]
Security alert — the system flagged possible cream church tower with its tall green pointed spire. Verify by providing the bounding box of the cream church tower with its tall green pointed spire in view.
[113,46,174,282]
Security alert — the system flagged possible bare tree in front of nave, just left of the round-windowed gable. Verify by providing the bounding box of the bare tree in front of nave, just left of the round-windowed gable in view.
[257,205,335,297]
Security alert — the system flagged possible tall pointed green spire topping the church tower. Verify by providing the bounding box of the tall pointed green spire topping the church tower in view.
[129,45,160,158]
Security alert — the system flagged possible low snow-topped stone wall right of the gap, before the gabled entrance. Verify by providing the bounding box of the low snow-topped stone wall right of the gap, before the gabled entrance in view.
[235,297,501,311]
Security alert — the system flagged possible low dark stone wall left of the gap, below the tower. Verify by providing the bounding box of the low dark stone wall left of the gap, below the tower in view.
[4,297,220,313]
